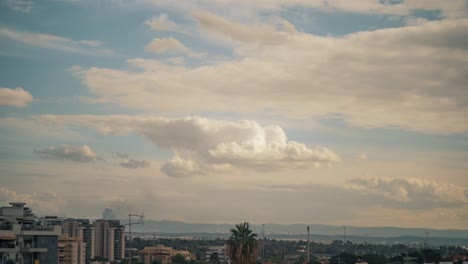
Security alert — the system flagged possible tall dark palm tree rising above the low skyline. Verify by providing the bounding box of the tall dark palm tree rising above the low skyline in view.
[226,222,259,264]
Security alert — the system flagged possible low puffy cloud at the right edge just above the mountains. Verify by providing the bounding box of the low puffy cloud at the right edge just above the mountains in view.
[350,177,468,209]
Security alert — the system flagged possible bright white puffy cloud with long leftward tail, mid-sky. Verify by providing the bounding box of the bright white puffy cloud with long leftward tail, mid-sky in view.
[35,115,340,177]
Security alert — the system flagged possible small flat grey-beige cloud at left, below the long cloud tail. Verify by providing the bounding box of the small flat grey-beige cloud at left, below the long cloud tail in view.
[34,145,100,162]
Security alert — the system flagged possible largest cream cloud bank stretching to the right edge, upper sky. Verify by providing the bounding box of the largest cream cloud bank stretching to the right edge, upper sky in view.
[71,19,468,134]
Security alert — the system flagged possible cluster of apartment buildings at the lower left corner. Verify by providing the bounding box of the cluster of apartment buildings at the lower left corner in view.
[0,203,125,264]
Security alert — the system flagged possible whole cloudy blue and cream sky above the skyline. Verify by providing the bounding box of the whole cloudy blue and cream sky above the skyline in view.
[0,0,468,229]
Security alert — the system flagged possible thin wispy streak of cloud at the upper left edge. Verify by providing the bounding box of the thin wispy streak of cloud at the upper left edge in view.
[0,27,113,56]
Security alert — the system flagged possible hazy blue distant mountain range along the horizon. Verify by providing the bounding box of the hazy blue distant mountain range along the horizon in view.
[121,220,468,245]
